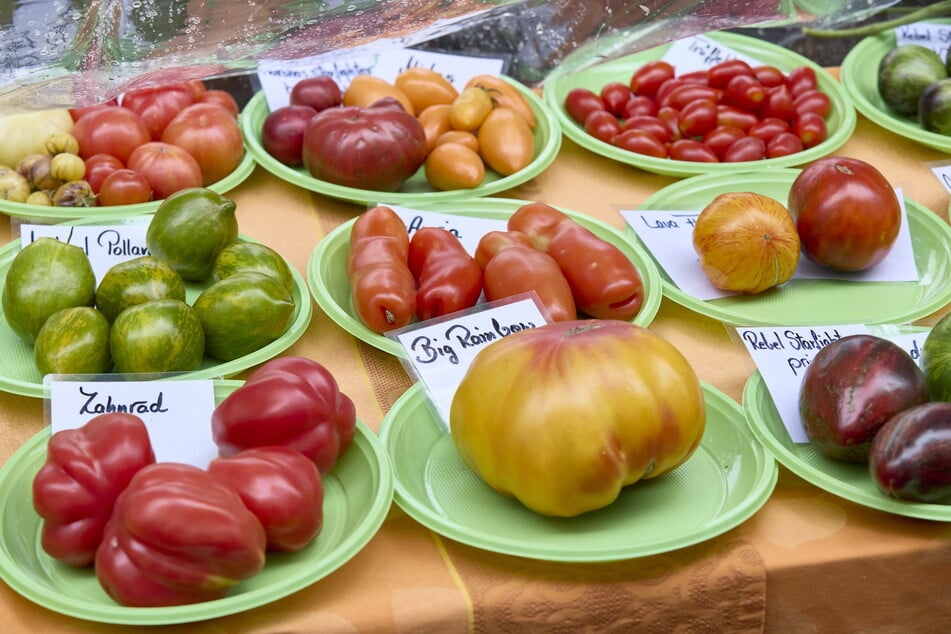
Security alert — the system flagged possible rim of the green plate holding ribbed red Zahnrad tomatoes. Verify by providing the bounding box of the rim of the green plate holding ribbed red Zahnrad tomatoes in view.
[0,380,394,625]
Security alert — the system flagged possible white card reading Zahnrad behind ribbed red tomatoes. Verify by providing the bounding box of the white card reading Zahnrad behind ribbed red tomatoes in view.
[45,375,218,469]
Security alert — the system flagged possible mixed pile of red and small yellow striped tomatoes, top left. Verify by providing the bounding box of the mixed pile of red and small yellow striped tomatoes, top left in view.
[0,80,244,207]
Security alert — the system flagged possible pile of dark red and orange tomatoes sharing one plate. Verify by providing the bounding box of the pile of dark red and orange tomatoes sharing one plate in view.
[261,68,536,191]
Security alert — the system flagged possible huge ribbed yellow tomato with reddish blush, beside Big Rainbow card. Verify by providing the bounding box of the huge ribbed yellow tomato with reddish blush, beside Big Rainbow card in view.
[449,320,706,517]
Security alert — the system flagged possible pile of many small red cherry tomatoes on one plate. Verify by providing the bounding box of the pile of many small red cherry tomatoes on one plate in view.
[564,59,831,163]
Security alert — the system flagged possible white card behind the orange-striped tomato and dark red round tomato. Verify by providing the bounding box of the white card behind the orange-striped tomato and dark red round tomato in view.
[620,191,918,301]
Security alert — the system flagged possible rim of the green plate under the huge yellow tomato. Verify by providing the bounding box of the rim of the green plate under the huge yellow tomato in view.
[379,381,779,563]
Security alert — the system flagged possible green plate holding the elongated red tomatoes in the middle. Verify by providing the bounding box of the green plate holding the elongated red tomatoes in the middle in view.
[307,198,663,357]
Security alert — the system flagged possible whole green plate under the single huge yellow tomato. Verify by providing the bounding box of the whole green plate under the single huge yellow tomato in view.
[380,384,778,562]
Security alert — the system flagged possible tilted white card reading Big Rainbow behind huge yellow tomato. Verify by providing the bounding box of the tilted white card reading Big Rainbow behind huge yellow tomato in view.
[387,293,548,429]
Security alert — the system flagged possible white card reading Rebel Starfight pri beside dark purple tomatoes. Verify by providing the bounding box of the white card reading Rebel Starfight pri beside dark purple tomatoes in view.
[736,324,928,443]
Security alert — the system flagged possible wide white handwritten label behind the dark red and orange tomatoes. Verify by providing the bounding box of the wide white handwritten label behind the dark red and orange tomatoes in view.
[258,48,502,112]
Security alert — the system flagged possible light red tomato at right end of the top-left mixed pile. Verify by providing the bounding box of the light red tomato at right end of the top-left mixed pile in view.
[162,103,244,187]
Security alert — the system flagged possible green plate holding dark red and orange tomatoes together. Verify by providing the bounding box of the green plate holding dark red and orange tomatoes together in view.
[241,77,561,206]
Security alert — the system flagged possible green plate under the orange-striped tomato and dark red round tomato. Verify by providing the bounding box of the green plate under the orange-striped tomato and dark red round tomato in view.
[628,169,951,326]
